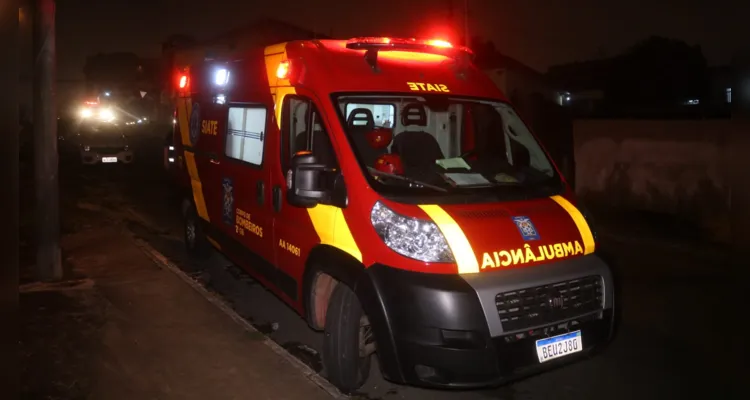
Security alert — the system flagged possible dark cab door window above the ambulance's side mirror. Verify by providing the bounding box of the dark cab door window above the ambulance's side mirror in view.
[281,96,337,172]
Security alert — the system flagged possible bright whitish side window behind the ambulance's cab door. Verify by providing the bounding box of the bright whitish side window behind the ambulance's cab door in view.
[225,106,266,166]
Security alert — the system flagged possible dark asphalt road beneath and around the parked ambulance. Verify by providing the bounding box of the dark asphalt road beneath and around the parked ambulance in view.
[54,129,750,400]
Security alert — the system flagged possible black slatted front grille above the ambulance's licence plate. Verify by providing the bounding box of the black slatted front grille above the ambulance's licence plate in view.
[495,275,604,332]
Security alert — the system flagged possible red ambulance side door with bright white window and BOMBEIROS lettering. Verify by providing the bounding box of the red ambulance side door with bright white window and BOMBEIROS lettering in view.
[219,103,275,270]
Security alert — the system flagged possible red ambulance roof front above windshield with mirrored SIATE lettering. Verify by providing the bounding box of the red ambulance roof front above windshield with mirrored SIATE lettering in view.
[286,40,507,100]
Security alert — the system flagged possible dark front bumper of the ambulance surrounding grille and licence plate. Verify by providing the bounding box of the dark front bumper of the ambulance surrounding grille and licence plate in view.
[356,255,615,389]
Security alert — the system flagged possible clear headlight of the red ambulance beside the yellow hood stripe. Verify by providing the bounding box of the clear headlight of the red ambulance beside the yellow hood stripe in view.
[370,201,455,262]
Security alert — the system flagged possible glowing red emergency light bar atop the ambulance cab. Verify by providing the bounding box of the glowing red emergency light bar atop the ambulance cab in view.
[346,37,474,72]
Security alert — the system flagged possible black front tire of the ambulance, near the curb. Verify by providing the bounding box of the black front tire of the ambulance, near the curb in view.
[323,283,372,394]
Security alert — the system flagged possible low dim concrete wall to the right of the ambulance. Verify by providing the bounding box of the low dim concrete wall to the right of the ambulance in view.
[573,120,750,244]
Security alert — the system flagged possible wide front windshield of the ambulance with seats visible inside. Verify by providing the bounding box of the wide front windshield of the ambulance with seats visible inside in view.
[336,95,561,198]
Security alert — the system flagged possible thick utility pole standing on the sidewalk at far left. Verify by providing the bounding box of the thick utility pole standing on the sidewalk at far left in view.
[34,0,62,281]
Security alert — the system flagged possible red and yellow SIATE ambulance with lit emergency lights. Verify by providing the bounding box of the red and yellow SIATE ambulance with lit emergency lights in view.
[174,38,615,392]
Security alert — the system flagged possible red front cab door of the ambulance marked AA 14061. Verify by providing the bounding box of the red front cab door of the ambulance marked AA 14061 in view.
[271,90,336,300]
